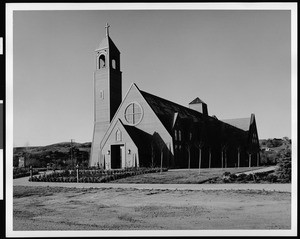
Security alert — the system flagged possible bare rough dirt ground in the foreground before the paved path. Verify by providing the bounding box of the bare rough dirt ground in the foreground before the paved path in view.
[13,186,291,231]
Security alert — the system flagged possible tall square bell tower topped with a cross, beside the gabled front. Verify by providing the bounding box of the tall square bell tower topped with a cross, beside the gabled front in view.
[89,24,122,166]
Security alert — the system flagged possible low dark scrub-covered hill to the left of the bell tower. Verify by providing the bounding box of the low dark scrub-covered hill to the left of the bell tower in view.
[13,142,91,167]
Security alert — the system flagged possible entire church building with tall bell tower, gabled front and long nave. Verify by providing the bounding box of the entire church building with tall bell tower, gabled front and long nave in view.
[89,25,260,169]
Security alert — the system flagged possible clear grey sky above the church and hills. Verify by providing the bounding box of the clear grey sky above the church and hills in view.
[13,6,291,147]
